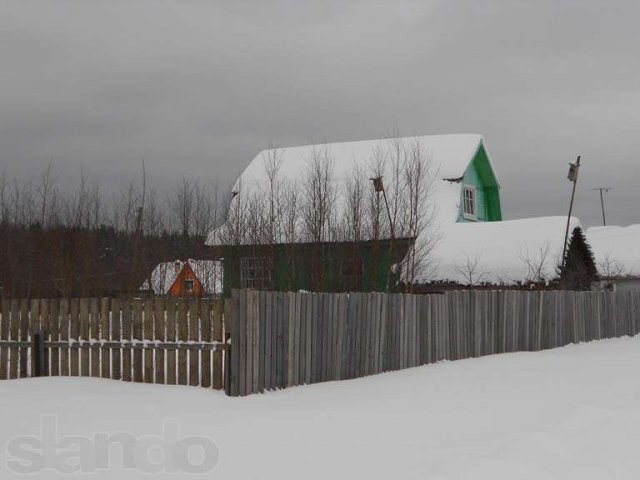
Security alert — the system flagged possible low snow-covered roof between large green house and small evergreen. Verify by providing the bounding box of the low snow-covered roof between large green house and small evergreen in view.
[425,217,580,285]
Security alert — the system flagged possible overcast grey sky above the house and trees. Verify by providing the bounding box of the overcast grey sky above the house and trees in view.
[0,0,640,225]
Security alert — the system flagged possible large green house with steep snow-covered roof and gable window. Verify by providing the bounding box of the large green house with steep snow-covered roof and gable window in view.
[207,134,502,294]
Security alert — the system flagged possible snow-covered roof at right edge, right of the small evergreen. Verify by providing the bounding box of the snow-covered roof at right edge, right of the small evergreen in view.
[586,224,640,277]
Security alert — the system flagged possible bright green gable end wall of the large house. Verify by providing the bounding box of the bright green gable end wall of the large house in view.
[458,143,502,222]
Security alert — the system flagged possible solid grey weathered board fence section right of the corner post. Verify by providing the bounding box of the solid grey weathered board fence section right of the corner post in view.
[227,290,640,396]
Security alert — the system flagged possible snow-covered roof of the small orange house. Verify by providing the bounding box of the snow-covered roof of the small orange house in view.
[140,259,223,295]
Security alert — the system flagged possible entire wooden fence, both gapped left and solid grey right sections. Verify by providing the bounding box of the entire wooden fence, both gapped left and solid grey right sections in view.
[6,290,640,396]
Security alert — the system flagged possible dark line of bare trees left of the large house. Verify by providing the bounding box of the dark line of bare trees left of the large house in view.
[0,163,225,298]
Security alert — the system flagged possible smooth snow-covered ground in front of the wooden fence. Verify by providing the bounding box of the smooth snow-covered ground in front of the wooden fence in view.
[0,337,640,480]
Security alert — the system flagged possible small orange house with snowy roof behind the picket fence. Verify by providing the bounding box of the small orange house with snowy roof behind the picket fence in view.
[140,259,223,297]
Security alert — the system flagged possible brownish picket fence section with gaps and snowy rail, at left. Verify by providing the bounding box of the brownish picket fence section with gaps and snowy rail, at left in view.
[0,298,226,390]
